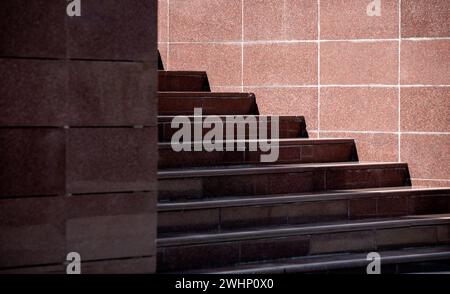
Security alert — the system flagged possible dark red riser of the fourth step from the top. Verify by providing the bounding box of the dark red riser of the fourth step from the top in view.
[158,143,356,169]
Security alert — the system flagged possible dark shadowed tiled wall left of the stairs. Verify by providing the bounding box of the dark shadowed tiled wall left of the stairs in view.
[0,0,157,273]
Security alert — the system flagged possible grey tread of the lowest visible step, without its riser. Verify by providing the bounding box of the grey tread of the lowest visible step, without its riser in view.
[184,246,450,274]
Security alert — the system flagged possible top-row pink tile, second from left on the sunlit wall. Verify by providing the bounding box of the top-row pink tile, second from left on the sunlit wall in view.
[244,0,318,40]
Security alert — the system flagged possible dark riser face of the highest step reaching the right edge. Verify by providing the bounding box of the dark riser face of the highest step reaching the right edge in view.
[158,193,450,234]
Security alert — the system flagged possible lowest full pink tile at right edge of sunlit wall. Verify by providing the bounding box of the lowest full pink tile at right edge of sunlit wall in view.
[401,134,450,179]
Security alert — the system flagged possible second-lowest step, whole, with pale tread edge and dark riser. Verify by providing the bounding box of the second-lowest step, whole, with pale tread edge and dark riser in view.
[157,214,450,272]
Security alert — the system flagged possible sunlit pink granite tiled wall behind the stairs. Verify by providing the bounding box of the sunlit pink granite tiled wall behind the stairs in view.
[159,0,450,186]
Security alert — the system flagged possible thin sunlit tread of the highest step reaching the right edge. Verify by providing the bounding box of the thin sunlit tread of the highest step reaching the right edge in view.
[158,186,450,211]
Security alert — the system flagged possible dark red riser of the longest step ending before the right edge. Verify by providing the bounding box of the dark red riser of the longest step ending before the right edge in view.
[158,167,411,200]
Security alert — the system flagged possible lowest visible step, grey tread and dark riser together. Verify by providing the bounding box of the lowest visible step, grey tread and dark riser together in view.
[181,246,450,275]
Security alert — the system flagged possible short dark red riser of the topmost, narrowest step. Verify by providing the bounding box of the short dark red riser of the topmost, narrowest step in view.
[158,70,211,92]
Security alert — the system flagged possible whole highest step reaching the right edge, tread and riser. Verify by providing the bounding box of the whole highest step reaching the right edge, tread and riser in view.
[158,187,450,234]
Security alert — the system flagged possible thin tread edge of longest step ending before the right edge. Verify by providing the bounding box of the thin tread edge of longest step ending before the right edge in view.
[158,162,408,179]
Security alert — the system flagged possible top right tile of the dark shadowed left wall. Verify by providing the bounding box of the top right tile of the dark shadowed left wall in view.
[67,0,158,62]
